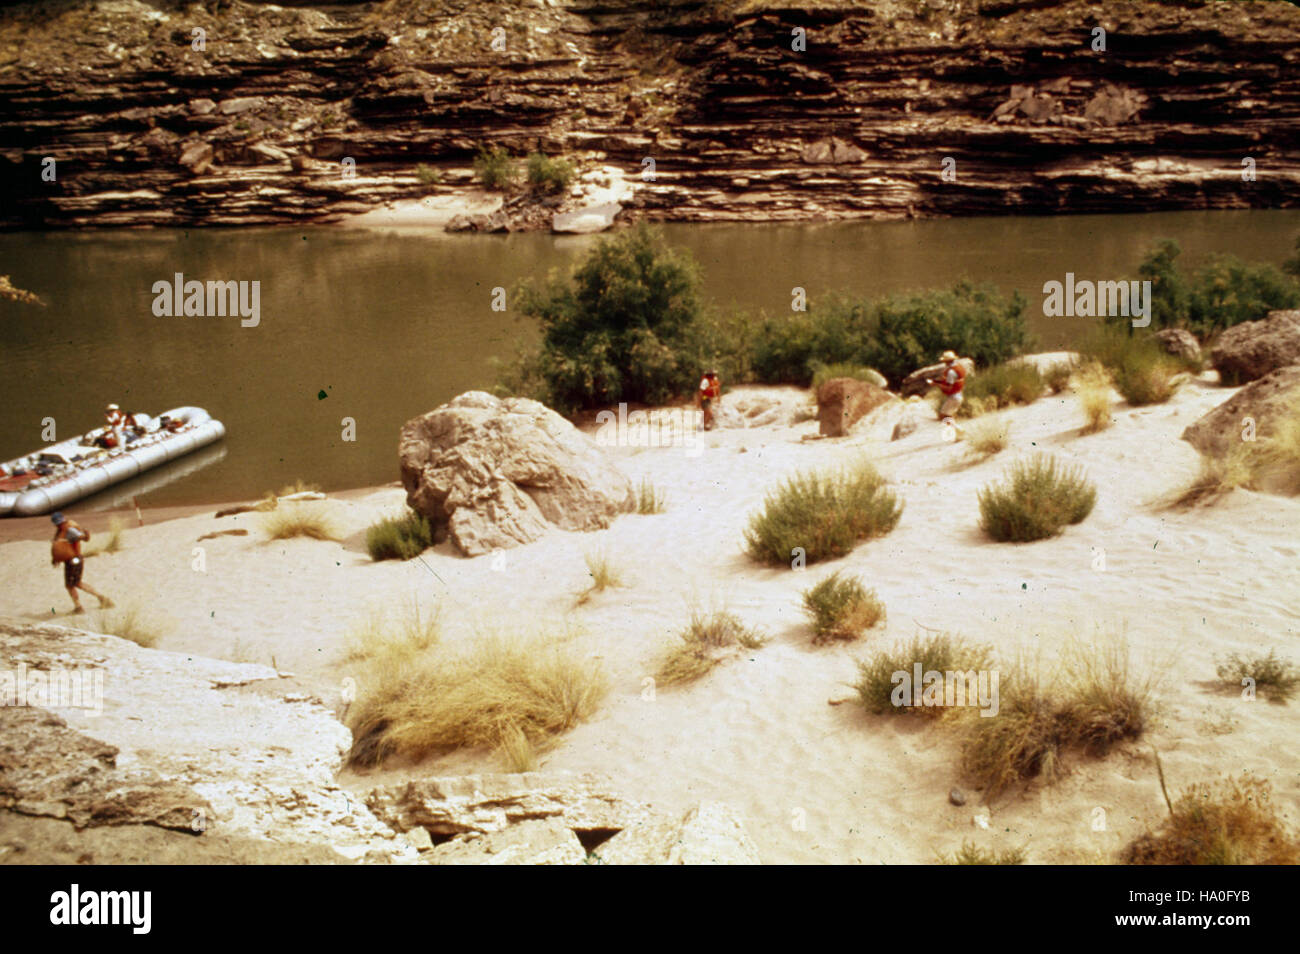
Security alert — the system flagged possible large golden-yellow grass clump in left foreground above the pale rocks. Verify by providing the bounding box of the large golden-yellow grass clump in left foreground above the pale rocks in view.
[347,636,610,766]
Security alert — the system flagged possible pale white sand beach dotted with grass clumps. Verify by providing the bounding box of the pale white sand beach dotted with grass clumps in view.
[0,382,1300,863]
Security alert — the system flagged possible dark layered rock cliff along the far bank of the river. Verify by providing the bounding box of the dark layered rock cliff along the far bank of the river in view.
[0,0,1300,227]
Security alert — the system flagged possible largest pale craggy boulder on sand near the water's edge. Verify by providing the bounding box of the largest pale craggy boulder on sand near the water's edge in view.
[398,391,636,556]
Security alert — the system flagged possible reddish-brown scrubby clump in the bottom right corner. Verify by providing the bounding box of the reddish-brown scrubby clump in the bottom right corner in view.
[1122,772,1300,864]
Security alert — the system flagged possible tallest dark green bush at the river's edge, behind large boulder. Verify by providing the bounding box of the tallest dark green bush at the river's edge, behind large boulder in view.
[515,226,706,411]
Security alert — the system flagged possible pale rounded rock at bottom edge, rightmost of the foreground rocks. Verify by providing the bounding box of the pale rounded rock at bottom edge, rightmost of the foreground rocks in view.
[593,802,761,864]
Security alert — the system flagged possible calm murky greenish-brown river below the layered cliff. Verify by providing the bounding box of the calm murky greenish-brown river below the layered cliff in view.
[0,211,1300,508]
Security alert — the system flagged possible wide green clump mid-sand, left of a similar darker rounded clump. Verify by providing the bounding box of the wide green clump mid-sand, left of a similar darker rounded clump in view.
[745,460,902,564]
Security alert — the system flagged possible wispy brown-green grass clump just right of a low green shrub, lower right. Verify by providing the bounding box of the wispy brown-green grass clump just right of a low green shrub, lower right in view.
[962,642,1154,798]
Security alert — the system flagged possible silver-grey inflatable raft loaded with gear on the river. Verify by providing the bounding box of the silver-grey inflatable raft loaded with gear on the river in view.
[0,407,226,517]
